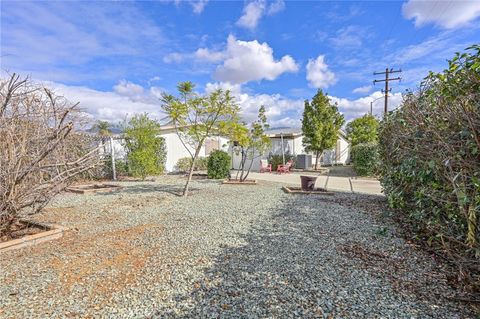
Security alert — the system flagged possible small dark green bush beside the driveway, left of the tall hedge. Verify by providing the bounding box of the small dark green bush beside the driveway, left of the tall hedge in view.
[351,143,378,176]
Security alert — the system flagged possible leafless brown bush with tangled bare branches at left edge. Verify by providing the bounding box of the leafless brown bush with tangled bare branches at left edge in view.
[0,74,99,236]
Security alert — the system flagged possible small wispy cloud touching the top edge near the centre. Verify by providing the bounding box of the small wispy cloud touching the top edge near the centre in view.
[237,0,285,30]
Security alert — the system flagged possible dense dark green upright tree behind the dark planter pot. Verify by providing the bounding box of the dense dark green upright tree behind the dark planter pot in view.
[302,90,345,169]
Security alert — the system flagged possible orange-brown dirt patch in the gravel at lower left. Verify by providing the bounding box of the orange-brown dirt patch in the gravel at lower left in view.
[48,224,163,303]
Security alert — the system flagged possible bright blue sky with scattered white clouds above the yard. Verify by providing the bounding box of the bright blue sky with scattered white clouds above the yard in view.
[0,0,480,126]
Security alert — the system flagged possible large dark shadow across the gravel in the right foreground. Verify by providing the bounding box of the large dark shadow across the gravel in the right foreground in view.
[151,191,465,318]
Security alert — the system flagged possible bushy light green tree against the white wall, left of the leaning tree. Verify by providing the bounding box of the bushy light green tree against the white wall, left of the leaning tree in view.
[124,114,167,180]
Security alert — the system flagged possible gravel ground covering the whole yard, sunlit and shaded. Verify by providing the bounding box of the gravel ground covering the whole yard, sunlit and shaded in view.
[0,176,474,318]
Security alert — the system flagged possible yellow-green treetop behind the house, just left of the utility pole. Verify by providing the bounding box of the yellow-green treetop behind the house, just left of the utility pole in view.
[347,114,380,147]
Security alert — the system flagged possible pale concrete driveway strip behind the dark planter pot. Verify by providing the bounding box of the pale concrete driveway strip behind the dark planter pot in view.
[249,172,382,195]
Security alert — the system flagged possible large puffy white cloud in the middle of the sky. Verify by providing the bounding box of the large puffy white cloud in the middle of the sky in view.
[214,35,299,84]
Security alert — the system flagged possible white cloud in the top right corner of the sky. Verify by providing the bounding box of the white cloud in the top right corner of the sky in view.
[402,0,480,29]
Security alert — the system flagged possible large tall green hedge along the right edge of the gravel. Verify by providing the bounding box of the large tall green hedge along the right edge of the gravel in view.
[379,45,480,293]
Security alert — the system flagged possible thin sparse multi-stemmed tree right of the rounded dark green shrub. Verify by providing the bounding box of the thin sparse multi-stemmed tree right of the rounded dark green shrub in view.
[232,105,271,182]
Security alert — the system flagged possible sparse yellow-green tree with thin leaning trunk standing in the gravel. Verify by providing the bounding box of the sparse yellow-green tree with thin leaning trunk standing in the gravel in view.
[162,82,239,196]
